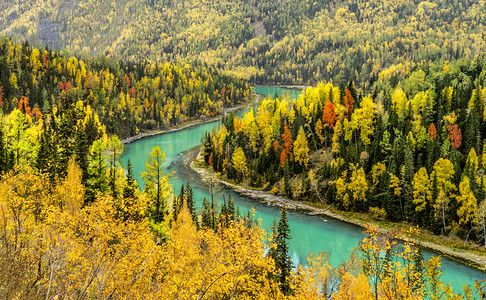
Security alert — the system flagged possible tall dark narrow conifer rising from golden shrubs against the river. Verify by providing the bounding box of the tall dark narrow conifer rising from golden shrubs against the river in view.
[273,207,292,295]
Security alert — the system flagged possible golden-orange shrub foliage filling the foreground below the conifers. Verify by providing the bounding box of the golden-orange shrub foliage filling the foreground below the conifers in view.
[0,160,480,300]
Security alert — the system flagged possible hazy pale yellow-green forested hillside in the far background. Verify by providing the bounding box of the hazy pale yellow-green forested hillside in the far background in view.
[0,0,486,88]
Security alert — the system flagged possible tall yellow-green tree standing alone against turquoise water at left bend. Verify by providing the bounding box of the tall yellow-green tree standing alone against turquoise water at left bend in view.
[141,146,171,224]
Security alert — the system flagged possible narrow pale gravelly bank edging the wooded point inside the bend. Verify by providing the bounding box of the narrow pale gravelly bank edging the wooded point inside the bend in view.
[189,151,486,272]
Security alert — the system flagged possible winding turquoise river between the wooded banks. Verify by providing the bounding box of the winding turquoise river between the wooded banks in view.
[122,87,486,291]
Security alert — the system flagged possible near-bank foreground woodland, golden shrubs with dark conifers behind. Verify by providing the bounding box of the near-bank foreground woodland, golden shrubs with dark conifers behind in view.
[0,54,483,299]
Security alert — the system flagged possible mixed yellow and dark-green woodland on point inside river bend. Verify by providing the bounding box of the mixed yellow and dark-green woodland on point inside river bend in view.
[203,56,486,245]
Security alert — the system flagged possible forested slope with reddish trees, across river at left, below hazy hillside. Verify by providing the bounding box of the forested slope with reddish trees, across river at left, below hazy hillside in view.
[0,38,251,138]
